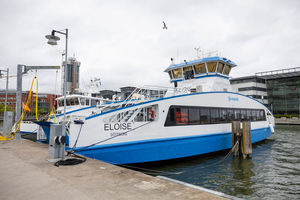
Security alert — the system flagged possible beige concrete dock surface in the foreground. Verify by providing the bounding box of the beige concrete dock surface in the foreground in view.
[0,140,230,200]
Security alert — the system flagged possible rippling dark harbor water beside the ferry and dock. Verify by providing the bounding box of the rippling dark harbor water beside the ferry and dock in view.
[138,125,300,199]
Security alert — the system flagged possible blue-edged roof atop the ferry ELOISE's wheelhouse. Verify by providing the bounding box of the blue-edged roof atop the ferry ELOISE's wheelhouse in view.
[164,56,237,72]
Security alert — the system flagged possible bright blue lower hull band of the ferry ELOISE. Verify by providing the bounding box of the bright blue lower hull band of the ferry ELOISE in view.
[74,127,272,164]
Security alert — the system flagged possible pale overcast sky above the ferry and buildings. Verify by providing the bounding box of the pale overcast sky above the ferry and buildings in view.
[0,0,300,92]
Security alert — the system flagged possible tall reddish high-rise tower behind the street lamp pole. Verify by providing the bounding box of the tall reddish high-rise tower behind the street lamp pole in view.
[61,58,80,94]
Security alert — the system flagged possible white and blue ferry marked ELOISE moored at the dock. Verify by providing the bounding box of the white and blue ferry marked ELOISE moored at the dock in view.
[68,57,275,164]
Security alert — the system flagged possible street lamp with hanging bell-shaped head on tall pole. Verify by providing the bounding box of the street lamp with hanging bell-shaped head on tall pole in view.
[45,29,68,123]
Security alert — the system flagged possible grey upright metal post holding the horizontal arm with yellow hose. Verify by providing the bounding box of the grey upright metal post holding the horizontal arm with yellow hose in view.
[14,65,24,140]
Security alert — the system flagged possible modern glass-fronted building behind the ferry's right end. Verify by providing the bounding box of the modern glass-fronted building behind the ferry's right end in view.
[230,67,300,116]
